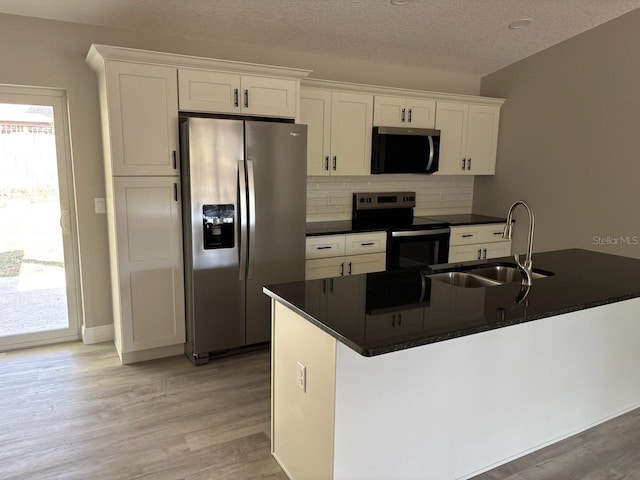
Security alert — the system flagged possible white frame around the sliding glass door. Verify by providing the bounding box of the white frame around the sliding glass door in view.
[0,84,84,351]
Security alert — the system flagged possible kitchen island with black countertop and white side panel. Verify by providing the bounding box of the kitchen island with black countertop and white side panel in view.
[265,250,640,480]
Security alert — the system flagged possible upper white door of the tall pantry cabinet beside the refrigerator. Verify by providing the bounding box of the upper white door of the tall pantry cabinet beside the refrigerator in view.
[103,61,179,176]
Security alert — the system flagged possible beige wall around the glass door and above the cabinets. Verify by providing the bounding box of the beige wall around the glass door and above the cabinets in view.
[0,15,480,327]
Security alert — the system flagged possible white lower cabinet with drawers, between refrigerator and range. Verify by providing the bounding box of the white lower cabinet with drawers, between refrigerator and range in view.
[305,232,387,280]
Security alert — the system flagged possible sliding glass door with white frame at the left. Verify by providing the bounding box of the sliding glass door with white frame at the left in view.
[0,86,80,351]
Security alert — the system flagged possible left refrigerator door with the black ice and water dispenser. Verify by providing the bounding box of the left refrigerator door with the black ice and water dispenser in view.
[181,118,245,356]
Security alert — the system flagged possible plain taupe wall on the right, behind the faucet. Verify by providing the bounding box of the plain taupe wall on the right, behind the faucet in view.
[474,10,640,258]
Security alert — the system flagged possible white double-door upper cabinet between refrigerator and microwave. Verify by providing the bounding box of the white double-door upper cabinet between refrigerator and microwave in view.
[300,88,373,175]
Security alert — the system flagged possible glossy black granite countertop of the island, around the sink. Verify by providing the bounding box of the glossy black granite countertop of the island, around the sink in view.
[264,249,640,356]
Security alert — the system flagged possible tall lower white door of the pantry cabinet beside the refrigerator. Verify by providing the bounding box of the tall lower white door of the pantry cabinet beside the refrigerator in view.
[110,177,185,363]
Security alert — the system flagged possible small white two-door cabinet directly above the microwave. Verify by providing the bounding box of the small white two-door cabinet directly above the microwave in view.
[373,95,436,128]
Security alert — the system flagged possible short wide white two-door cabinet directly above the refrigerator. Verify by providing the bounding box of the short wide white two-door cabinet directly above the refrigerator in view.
[178,68,297,118]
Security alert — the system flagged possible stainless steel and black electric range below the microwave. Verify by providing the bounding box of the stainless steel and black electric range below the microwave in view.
[352,192,450,270]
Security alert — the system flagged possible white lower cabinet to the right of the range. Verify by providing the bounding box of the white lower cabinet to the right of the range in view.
[449,223,511,263]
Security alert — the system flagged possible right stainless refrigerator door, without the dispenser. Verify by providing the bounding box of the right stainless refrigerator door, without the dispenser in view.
[245,122,307,344]
